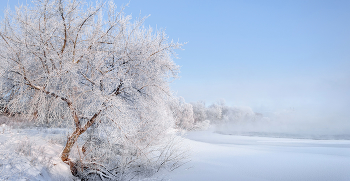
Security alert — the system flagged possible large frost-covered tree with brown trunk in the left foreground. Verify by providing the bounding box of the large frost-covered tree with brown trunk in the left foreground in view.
[0,0,185,179]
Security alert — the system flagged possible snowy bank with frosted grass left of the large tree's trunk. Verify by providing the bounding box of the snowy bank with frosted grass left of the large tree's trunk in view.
[0,124,73,181]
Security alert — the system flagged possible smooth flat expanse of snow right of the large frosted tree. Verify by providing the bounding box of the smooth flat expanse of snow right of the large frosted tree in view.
[171,131,350,181]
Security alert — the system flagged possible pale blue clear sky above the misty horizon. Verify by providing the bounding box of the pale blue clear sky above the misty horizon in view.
[0,0,350,122]
